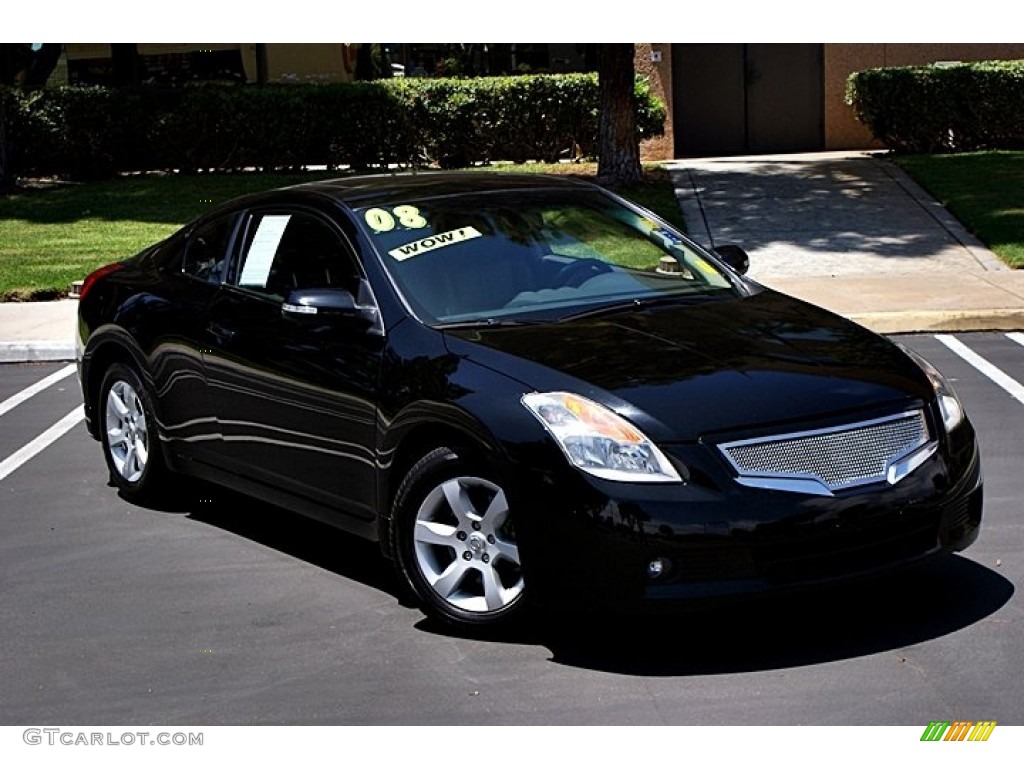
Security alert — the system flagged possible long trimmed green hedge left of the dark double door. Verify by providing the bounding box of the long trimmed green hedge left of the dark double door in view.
[0,75,666,178]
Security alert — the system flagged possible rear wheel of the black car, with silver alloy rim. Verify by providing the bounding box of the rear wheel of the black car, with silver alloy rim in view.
[99,362,167,501]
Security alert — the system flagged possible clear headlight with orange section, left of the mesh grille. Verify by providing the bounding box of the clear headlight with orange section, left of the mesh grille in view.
[522,392,681,482]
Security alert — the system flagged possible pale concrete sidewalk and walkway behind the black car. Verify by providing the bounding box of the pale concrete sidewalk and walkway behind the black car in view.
[6,152,1024,362]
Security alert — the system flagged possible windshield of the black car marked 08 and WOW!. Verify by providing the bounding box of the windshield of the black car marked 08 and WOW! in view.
[356,190,735,325]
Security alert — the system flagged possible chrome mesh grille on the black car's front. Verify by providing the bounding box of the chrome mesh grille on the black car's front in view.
[719,411,929,490]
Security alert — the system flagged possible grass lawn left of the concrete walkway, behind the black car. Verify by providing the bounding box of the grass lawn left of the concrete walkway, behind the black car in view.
[0,163,683,301]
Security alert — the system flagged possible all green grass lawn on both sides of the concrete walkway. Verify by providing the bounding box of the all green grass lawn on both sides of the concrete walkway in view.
[6,152,1024,301]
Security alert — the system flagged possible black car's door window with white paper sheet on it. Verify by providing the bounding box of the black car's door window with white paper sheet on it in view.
[233,213,359,299]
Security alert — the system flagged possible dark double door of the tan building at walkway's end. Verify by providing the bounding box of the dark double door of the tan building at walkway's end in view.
[672,43,824,157]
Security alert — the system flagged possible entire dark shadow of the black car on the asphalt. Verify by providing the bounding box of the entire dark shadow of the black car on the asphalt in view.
[119,479,1014,677]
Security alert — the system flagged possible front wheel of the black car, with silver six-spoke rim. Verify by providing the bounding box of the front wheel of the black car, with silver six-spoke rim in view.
[394,447,524,627]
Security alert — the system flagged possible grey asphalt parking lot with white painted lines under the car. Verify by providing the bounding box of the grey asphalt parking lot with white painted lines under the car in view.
[0,333,1024,726]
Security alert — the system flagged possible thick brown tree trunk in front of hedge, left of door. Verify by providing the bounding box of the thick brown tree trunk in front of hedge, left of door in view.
[597,43,643,186]
